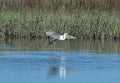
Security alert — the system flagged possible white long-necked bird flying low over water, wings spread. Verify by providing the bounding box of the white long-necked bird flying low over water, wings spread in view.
[46,32,76,40]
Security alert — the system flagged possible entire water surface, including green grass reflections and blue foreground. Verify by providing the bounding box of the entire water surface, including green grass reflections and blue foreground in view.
[0,39,120,83]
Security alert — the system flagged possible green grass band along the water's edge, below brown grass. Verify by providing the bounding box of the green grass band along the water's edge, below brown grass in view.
[0,11,120,39]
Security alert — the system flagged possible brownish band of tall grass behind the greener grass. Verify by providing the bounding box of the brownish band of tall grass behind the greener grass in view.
[0,0,120,12]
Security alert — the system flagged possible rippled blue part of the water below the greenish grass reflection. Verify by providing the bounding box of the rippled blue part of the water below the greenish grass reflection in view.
[0,51,120,83]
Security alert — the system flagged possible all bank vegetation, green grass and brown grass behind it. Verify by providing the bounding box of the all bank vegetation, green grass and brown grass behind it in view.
[0,0,120,39]
